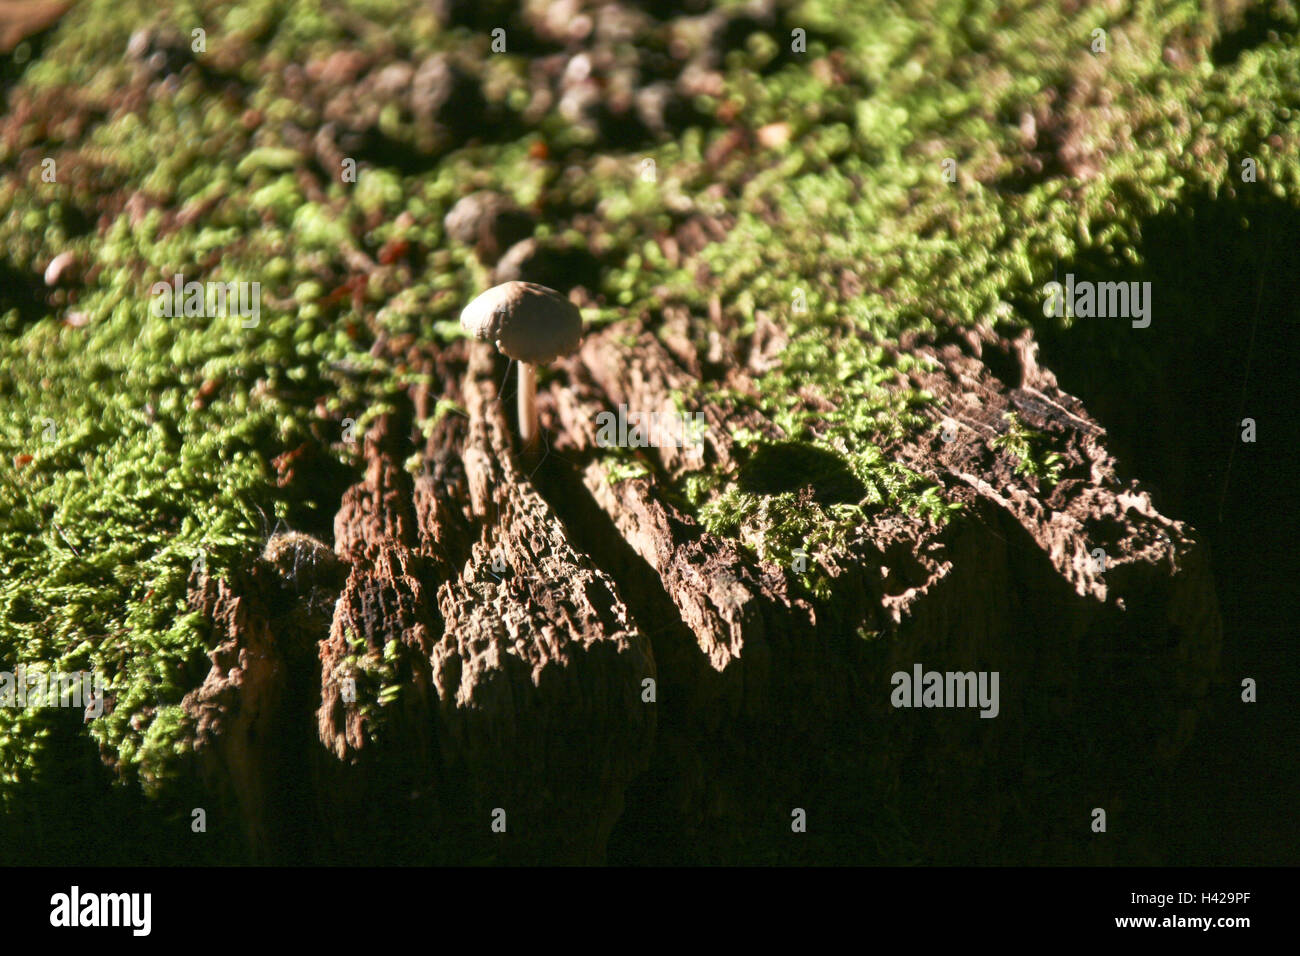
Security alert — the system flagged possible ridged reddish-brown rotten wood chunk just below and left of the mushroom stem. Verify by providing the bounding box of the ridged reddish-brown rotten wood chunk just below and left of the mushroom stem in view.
[320,346,655,861]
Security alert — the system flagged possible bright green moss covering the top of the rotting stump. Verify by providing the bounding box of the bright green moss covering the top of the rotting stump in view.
[0,0,1300,853]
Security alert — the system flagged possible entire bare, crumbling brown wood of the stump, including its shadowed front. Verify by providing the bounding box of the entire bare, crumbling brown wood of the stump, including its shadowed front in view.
[180,316,1219,862]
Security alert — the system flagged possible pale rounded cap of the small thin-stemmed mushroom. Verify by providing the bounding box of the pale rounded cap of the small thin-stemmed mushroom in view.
[460,282,582,365]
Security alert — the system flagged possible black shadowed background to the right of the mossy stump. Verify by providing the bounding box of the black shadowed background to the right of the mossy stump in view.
[1023,183,1300,865]
